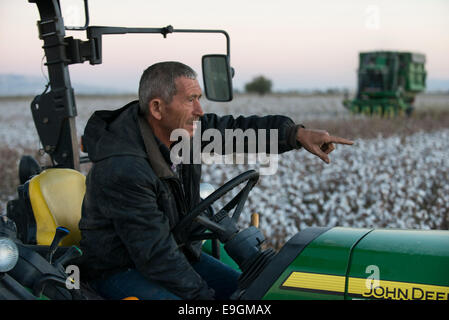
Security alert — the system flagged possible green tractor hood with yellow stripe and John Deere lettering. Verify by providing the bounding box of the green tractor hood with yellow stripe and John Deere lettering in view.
[242,227,449,300]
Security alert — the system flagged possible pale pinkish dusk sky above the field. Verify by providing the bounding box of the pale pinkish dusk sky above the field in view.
[0,0,449,91]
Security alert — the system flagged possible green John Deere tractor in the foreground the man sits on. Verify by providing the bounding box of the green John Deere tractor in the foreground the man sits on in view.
[0,0,449,302]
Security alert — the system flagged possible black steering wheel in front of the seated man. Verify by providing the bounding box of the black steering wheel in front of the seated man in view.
[173,170,259,244]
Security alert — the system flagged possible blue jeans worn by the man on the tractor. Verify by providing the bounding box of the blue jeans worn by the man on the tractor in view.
[92,252,240,300]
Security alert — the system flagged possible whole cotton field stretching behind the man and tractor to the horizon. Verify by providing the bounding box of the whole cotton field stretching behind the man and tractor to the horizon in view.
[0,95,449,247]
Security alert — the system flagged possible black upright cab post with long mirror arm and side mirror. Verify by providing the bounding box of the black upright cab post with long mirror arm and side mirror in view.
[29,0,234,170]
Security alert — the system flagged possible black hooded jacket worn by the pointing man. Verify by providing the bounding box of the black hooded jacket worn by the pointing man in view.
[79,101,300,299]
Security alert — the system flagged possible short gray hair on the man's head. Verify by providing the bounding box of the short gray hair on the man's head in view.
[139,61,197,116]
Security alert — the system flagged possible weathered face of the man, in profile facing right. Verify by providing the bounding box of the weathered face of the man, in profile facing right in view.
[161,77,204,136]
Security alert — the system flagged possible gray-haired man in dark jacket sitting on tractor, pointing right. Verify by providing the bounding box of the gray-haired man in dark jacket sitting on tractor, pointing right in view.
[79,62,353,299]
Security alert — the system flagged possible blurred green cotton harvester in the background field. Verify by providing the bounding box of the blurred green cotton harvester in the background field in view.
[343,51,426,117]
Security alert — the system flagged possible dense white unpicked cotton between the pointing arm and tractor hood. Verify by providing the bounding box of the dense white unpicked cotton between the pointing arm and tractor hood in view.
[203,129,449,246]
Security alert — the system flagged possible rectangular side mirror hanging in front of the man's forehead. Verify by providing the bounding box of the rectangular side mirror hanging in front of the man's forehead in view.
[202,54,233,102]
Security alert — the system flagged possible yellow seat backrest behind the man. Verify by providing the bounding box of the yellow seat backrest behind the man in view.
[28,168,86,246]
